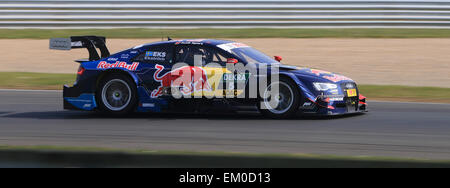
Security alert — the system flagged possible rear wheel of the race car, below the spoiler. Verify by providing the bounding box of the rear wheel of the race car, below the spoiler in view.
[96,73,138,115]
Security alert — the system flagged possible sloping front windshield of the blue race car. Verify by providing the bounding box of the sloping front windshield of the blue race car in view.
[218,43,279,64]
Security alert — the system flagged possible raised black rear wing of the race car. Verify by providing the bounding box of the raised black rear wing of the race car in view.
[50,36,110,61]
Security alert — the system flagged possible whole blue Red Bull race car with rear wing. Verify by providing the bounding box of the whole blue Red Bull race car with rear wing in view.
[50,36,367,118]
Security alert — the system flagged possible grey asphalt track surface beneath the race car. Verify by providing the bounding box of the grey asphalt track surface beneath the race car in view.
[0,90,450,159]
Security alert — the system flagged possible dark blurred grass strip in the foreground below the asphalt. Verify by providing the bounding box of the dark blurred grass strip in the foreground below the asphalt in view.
[0,146,450,168]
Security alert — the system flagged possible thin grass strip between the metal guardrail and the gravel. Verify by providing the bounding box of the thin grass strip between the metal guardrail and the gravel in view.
[0,28,450,39]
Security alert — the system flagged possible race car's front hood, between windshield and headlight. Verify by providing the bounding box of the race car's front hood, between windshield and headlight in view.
[280,65,353,83]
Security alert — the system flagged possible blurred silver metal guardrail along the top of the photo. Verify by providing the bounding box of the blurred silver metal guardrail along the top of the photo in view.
[0,0,450,28]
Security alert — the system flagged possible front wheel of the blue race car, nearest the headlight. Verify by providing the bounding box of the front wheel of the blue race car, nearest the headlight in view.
[259,77,302,119]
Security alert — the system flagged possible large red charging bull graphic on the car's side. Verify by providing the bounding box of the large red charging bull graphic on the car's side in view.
[151,65,212,98]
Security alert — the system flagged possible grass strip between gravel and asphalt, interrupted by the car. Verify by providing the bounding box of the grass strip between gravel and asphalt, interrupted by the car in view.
[0,72,450,103]
